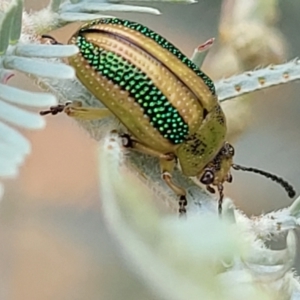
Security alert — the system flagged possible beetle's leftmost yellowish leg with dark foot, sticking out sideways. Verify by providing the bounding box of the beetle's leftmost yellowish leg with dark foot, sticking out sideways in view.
[40,101,112,120]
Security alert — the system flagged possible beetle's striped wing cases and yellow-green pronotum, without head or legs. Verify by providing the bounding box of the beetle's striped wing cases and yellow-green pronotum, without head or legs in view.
[69,18,226,176]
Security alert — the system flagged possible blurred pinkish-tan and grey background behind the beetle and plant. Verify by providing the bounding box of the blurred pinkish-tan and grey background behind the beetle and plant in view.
[0,0,300,300]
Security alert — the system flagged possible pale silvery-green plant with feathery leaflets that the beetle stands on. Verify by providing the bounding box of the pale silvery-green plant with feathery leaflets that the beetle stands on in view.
[0,0,300,300]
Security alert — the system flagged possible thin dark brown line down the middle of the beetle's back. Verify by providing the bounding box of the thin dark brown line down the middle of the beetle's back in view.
[79,28,202,106]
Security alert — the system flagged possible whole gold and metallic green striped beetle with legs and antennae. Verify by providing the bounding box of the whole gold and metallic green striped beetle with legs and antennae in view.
[41,18,295,215]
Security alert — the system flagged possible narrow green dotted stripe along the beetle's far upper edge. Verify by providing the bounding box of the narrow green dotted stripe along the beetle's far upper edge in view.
[79,18,216,95]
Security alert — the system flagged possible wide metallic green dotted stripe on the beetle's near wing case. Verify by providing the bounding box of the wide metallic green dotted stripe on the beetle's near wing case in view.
[75,35,189,144]
